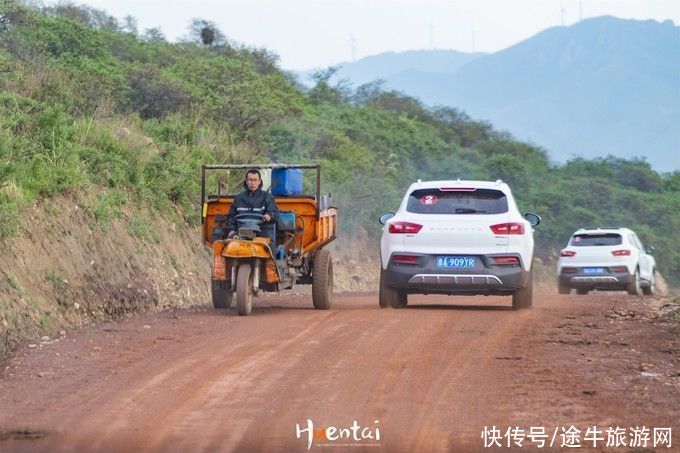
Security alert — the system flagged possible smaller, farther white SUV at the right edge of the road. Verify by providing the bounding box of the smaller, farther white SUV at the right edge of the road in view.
[557,228,656,296]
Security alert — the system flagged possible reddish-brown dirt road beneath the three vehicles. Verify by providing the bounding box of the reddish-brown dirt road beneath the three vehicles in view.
[0,294,680,452]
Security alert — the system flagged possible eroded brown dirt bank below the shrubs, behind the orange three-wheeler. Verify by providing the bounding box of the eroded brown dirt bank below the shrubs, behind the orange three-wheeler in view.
[0,194,378,359]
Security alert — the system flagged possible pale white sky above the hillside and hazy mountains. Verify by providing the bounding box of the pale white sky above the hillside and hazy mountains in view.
[45,0,680,70]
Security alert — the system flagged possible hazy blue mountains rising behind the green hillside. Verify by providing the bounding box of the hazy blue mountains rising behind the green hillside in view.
[300,16,680,170]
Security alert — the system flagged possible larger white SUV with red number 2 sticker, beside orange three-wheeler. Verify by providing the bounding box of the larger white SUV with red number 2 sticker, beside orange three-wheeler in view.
[379,180,541,308]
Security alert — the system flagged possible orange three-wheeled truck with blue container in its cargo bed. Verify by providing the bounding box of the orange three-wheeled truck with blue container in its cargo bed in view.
[201,164,338,315]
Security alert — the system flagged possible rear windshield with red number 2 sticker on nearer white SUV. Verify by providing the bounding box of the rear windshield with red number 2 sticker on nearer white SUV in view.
[406,189,508,214]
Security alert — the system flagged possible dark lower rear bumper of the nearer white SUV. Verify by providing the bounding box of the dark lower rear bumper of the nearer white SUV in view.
[384,255,529,295]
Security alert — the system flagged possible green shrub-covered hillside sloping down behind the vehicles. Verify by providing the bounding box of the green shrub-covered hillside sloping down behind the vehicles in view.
[0,1,680,285]
